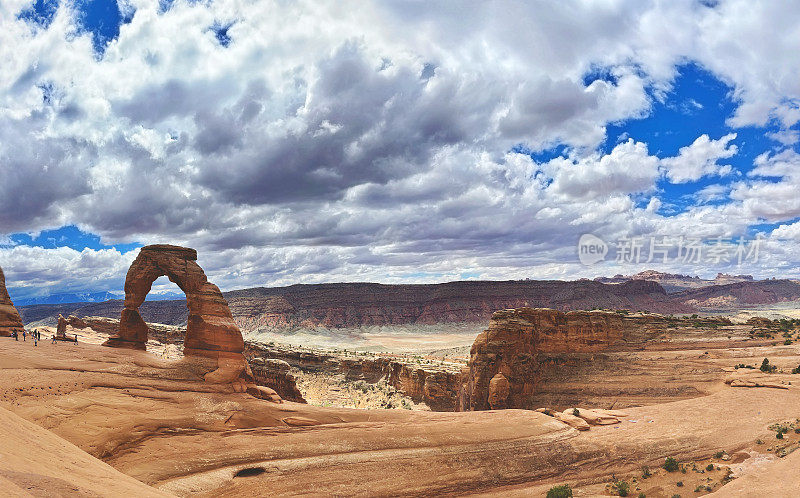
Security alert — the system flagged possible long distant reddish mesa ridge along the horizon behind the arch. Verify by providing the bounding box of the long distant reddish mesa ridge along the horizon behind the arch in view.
[18,272,800,333]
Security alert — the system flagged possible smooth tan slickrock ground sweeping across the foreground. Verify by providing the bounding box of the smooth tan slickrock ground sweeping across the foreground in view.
[0,322,800,498]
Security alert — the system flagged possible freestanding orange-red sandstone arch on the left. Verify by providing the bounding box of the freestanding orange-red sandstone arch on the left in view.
[105,244,244,360]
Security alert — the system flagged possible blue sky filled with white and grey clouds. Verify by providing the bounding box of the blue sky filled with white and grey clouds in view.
[0,0,800,302]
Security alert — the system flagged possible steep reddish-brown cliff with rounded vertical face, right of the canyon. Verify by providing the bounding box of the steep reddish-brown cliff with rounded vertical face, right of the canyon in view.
[460,308,624,411]
